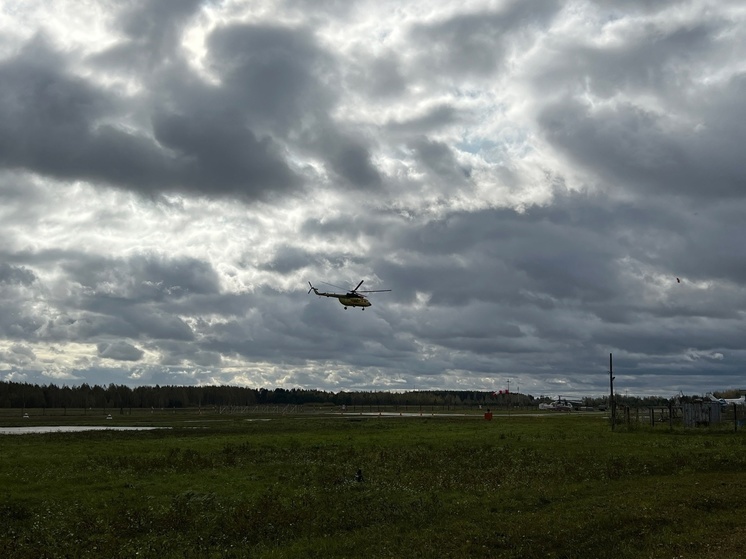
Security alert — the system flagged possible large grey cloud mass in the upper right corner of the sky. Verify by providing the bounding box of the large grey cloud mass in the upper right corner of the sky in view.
[533,13,746,199]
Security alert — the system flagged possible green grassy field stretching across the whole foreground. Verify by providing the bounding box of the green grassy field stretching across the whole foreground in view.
[0,410,746,559]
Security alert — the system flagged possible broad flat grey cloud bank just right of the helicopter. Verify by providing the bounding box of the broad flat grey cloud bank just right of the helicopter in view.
[368,189,744,384]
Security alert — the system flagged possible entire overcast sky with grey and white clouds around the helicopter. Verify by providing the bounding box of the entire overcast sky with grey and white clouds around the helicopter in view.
[0,0,746,396]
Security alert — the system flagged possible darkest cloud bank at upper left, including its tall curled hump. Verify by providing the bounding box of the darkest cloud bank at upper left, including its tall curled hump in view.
[0,10,392,201]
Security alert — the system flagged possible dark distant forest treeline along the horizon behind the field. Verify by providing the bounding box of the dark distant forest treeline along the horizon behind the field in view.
[0,382,668,409]
